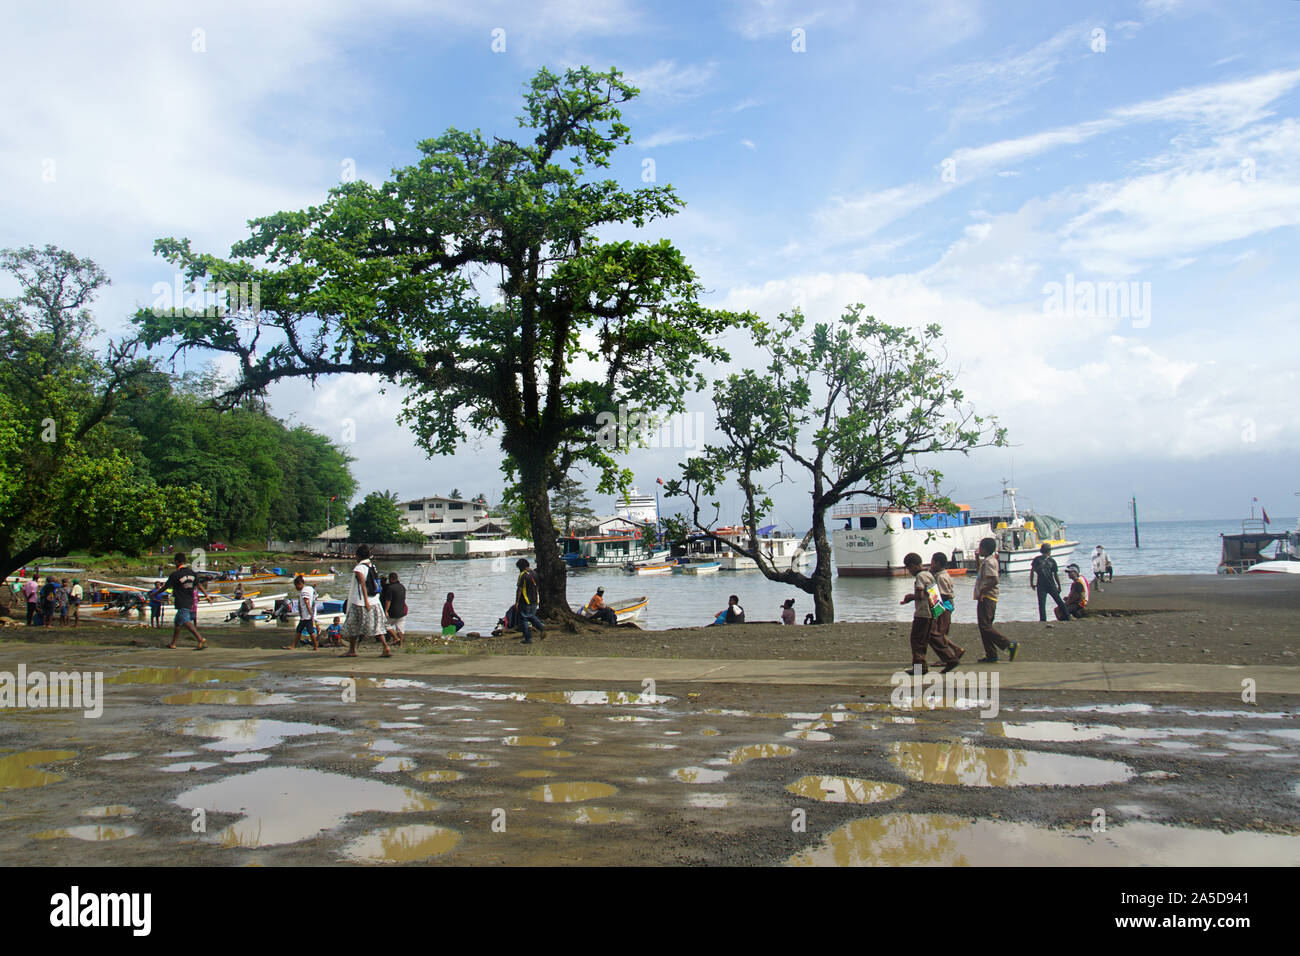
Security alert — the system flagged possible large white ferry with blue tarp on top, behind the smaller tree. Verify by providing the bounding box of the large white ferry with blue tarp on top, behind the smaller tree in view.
[831,501,993,578]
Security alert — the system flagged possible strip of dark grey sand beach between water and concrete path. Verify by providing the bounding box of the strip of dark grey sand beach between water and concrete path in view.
[0,575,1300,665]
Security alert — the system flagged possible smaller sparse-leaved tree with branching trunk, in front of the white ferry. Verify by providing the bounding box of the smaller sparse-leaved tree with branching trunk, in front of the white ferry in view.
[667,304,1006,623]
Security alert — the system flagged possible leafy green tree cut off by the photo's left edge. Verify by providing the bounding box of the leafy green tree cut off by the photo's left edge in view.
[0,246,203,575]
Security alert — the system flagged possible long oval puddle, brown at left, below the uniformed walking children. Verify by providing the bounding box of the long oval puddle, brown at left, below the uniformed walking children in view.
[889,743,1134,787]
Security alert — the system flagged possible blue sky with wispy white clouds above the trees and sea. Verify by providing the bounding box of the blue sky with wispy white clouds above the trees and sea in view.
[0,0,1300,528]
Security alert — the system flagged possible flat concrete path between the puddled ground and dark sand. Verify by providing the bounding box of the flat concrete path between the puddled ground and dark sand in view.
[0,643,1300,698]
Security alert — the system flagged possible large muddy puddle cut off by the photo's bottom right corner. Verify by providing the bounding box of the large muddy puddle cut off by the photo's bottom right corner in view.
[788,813,1300,866]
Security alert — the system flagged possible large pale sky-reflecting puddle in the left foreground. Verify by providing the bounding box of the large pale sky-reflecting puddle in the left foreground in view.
[173,767,438,848]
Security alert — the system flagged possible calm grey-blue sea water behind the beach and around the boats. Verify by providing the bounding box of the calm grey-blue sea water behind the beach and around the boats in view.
[304,518,1295,632]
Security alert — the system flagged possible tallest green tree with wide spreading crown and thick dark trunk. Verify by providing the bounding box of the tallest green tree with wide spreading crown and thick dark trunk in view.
[137,68,737,615]
